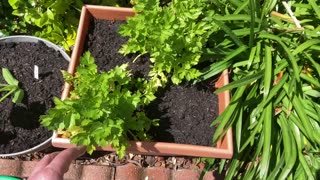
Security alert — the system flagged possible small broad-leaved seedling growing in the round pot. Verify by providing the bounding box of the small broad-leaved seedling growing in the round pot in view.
[0,68,24,103]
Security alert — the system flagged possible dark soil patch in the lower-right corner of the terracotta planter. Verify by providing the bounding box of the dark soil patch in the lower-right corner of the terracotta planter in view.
[146,83,219,146]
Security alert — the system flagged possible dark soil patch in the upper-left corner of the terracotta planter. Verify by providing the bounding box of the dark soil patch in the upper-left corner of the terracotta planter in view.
[84,19,150,78]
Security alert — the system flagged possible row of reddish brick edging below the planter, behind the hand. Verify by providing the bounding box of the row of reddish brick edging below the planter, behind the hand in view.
[0,159,223,180]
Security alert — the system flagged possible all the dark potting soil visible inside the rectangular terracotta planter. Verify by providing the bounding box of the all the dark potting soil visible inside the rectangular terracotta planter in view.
[84,19,218,146]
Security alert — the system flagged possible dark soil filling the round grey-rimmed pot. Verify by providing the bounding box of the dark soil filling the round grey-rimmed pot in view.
[0,42,68,154]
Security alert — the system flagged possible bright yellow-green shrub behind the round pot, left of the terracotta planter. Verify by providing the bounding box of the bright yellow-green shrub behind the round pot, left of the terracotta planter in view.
[8,0,83,51]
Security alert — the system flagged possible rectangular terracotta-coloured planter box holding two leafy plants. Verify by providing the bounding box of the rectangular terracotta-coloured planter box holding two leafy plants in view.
[52,5,233,158]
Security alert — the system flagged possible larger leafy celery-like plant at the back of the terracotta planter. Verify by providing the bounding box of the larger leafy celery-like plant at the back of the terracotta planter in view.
[119,0,214,87]
